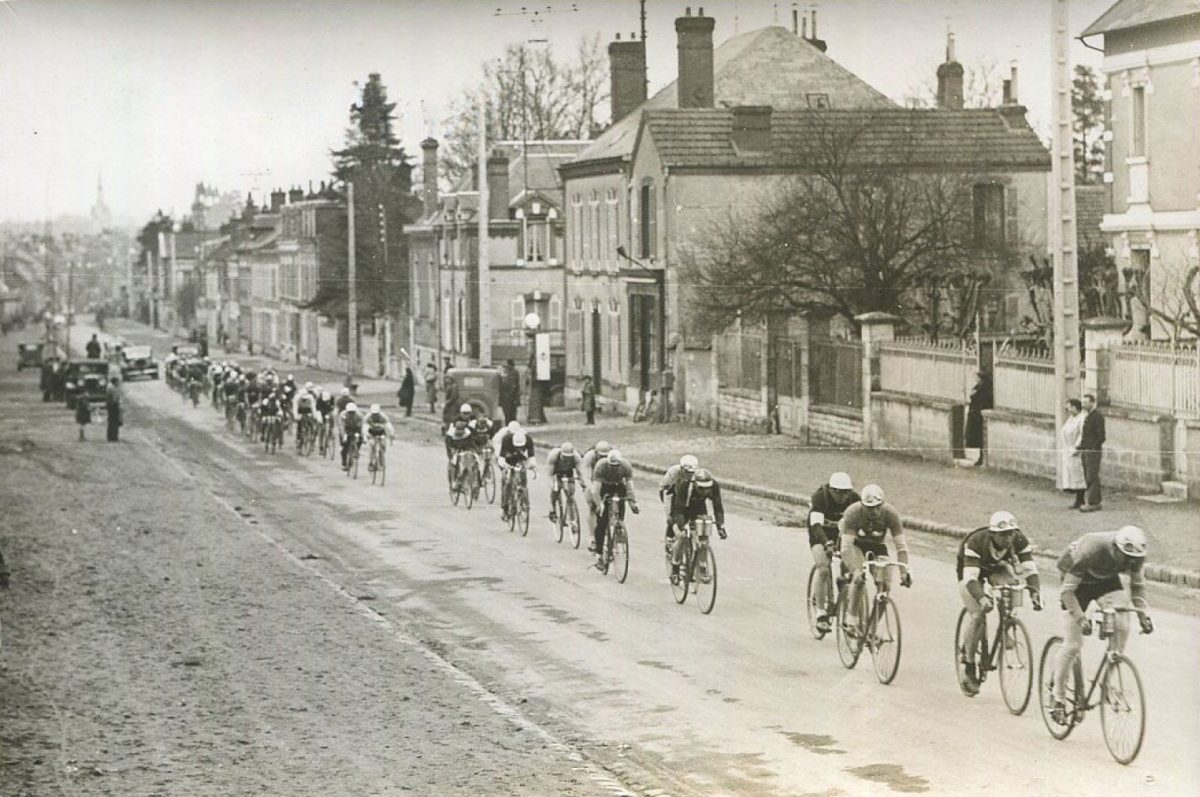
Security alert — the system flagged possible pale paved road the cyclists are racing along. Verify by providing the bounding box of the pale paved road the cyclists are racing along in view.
[112,350,1200,796]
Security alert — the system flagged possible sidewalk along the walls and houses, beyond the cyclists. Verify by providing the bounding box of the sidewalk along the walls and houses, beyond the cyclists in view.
[100,322,1200,588]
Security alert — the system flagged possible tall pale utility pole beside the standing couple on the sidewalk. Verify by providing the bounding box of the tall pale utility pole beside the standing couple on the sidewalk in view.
[1049,0,1079,475]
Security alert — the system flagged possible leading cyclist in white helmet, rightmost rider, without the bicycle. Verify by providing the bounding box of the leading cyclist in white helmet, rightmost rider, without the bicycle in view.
[1051,526,1154,724]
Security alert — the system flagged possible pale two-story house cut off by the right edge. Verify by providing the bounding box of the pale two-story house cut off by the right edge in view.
[1080,0,1200,338]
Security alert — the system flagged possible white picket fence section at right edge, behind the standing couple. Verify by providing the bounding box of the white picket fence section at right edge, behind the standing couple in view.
[1109,341,1200,418]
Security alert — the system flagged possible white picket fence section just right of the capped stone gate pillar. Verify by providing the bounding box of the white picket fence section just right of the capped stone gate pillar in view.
[880,337,979,403]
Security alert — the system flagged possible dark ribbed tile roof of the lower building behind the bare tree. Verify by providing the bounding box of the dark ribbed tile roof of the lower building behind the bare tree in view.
[646,108,1050,169]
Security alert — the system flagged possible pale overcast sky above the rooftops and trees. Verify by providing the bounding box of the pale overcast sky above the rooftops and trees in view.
[0,0,1114,224]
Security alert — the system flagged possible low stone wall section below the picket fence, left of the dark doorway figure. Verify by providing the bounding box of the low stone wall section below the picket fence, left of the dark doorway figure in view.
[871,391,962,463]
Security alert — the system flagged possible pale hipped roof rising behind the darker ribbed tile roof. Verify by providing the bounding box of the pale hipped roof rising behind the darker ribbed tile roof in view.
[575,26,895,163]
